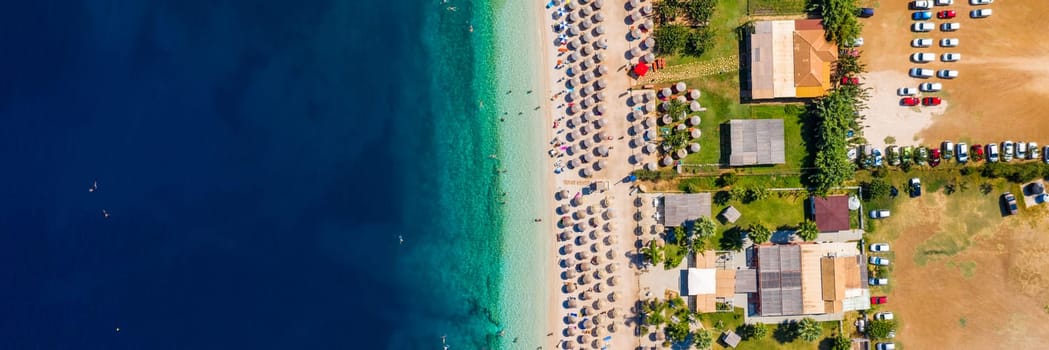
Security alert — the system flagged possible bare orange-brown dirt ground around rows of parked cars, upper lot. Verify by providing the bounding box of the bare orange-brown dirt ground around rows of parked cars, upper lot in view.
[861,0,1049,145]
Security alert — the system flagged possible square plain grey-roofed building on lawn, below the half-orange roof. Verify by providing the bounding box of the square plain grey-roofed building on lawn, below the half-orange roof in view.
[728,119,787,167]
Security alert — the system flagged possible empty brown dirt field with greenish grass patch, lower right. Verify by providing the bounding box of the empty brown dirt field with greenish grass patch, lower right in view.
[876,189,1049,349]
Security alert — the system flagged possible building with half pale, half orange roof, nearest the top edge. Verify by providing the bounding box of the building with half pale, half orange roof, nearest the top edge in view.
[749,20,838,100]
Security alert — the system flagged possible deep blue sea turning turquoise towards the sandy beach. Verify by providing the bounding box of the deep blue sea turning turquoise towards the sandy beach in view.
[0,0,552,349]
